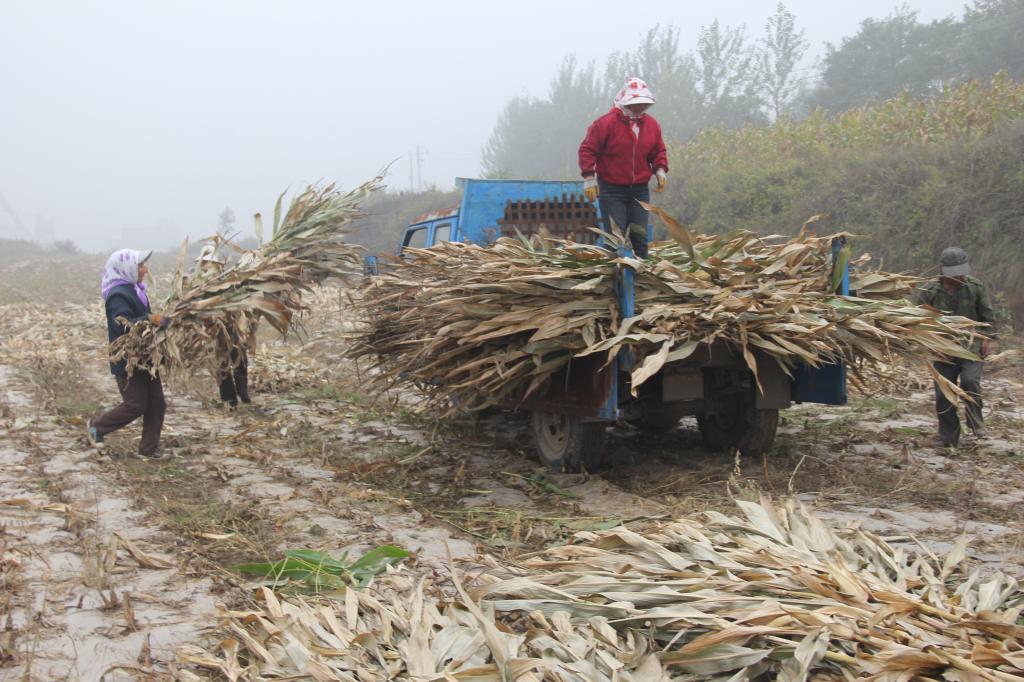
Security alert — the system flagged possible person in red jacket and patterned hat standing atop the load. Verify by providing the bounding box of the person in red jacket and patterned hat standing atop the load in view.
[580,78,669,258]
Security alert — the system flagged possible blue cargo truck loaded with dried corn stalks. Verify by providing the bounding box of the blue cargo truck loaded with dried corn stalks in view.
[367,178,849,472]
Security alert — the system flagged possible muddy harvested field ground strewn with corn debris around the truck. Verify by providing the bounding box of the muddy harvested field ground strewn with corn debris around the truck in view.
[0,251,1024,680]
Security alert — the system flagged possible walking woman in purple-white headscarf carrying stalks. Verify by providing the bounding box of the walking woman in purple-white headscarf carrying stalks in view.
[86,249,169,459]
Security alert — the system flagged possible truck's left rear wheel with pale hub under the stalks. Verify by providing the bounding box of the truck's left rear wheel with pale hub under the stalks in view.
[532,412,604,473]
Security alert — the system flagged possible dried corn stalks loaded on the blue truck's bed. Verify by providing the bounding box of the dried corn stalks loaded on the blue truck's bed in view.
[352,207,981,412]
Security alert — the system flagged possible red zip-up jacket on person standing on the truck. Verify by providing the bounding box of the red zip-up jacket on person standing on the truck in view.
[580,108,669,184]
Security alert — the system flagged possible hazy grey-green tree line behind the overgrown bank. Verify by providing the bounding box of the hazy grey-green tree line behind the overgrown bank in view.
[481,0,1024,179]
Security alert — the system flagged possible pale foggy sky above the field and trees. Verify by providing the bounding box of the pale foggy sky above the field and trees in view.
[0,0,963,251]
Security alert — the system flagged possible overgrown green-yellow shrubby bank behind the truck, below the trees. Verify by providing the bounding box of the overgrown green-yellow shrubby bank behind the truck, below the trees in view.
[658,78,1024,324]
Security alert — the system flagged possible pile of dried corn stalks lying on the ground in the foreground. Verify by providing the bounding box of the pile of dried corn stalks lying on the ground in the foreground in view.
[179,493,1024,682]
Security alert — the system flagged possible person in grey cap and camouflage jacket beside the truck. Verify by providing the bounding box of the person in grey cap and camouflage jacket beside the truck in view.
[918,247,995,447]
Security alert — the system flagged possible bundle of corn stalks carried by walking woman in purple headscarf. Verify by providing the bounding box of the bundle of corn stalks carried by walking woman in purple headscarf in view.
[111,177,382,376]
